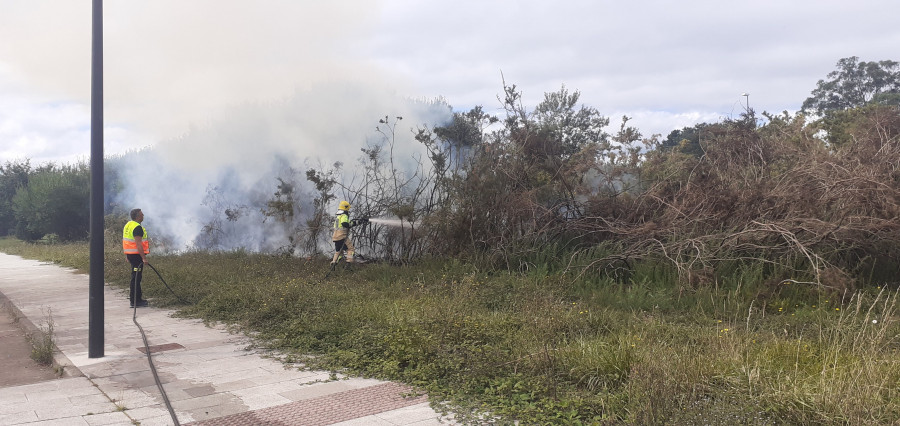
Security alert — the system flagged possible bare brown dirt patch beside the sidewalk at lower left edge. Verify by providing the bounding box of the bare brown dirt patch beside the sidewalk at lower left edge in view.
[0,303,57,388]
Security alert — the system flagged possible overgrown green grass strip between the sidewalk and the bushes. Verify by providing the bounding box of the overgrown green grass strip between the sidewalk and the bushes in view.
[0,239,900,424]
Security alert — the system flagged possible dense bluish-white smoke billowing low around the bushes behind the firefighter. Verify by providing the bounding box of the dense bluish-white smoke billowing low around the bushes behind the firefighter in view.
[116,84,451,251]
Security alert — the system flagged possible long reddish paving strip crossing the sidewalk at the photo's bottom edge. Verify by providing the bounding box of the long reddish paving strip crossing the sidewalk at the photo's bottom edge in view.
[189,383,428,426]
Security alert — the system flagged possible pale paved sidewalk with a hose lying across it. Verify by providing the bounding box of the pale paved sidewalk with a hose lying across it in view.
[0,253,452,426]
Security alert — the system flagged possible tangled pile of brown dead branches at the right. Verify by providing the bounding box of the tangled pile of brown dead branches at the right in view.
[573,108,900,291]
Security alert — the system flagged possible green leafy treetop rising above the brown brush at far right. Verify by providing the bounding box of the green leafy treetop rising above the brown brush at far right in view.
[802,56,900,114]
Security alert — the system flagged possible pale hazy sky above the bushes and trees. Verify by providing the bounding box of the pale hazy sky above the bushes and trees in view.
[0,0,900,163]
